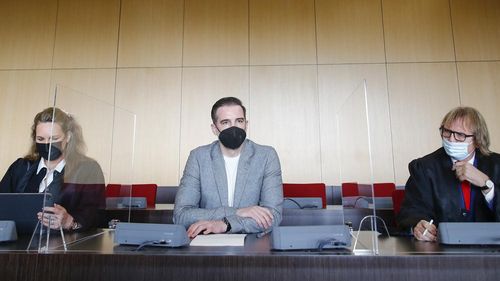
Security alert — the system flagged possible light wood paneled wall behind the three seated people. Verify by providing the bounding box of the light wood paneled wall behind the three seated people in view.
[0,0,500,185]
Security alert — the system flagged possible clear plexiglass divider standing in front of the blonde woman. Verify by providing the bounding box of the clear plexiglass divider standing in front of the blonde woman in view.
[27,84,136,253]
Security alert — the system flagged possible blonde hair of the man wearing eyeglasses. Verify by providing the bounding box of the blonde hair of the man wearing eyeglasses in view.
[441,106,491,155]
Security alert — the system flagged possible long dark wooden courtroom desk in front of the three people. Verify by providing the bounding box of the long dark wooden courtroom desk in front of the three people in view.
[0,230,500,281]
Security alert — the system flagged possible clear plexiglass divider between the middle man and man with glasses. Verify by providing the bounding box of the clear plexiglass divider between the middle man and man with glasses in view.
[336,80,389,255]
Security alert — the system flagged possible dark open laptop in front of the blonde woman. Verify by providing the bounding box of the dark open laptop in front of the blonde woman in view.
[0,193,53,235]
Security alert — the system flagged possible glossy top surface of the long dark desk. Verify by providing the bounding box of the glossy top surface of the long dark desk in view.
[0,229,500,256]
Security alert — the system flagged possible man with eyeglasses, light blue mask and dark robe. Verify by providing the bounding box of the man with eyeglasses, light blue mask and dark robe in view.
[397,107,500,241]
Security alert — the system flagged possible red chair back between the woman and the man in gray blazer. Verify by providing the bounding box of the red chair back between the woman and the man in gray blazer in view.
[106,183,158,208]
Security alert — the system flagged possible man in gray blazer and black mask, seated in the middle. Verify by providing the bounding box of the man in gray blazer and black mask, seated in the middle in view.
[174,97,283,237]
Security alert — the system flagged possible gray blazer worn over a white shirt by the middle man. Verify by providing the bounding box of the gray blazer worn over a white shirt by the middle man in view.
[173,139,283,233]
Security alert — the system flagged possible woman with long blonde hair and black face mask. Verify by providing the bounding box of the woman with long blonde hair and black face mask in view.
[0,107,104,231]
